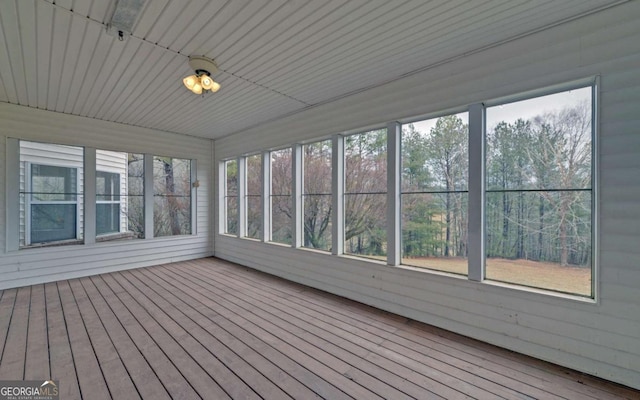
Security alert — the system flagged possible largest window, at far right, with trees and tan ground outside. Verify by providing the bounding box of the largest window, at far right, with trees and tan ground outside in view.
[486,87,593,296]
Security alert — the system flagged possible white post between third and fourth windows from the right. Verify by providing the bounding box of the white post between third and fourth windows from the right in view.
[331,135,344,255]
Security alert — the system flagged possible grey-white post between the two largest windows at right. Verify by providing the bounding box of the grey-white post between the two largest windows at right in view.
[468,104,485,282]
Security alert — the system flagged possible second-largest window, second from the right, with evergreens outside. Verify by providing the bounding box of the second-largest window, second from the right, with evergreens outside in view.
[401,113,469,275]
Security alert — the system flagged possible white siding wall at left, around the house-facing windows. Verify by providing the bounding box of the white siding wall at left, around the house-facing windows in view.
[0,103,213,289]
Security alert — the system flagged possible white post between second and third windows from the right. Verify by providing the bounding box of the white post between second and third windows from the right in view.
[387,122,402,266]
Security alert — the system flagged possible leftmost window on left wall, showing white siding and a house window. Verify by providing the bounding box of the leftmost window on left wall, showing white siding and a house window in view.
[20,141,84,247]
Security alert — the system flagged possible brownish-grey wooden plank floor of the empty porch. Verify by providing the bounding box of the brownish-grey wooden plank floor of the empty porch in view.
[0,258,640,400]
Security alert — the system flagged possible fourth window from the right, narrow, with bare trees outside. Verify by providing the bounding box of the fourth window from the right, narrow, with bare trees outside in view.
[302,140,332,251]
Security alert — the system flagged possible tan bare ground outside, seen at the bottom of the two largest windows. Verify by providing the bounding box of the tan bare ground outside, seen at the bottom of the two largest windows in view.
[402,257,591,296]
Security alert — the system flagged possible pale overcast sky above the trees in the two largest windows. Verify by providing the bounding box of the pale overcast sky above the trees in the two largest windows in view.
[404,87,591,133]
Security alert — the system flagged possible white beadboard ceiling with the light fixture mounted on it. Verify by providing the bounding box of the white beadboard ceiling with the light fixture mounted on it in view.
[0,0,620,139]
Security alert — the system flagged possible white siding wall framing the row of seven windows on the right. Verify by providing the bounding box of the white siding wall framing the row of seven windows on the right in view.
[215,1,640,388]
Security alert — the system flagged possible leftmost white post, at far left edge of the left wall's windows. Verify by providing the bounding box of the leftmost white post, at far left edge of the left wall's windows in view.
[5,138,19,252]
